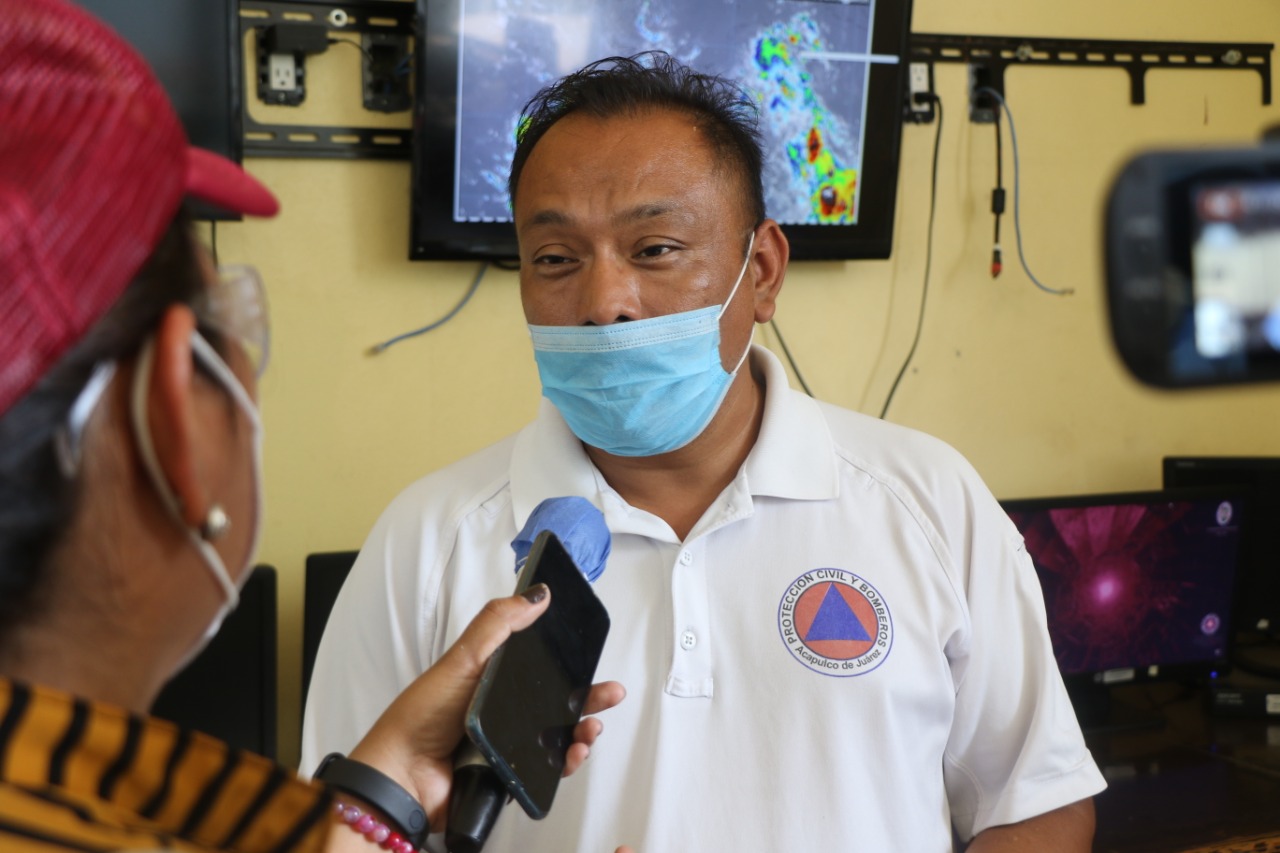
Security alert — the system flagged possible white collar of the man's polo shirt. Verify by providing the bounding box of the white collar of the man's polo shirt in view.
[511,345,840,535]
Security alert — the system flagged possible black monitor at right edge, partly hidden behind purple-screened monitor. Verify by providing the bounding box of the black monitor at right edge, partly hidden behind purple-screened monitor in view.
[1164,456,1280,631]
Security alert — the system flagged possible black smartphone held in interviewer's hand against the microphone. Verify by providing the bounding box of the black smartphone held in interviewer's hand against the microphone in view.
[466,530,609,820]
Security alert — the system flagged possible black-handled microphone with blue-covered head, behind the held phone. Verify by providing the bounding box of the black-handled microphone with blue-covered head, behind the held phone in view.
[444,497,612,853]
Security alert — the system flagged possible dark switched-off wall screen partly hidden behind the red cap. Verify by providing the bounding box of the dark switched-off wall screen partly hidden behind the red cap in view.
[76,0,244,219]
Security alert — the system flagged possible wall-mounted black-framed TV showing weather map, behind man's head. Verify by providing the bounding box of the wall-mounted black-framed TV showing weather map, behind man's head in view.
[410,0,911,260]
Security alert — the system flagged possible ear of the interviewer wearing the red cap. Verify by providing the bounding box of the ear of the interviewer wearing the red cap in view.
[147,305,207,528]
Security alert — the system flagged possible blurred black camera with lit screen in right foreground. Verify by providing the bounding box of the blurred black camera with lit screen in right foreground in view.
[1106,143,1280,388]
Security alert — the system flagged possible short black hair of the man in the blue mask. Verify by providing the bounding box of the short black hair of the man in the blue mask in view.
[507,50,764,225]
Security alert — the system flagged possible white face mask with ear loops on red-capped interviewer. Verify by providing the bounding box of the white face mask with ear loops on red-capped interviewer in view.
[131,332,262,672]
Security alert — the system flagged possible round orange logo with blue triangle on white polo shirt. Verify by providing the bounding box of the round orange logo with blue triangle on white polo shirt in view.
[778,569,893,678]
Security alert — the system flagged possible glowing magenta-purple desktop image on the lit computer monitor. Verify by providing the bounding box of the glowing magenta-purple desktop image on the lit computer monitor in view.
[1005,497,1240,675]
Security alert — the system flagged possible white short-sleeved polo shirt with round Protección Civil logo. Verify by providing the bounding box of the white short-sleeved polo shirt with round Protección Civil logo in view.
[302,347,1105,853]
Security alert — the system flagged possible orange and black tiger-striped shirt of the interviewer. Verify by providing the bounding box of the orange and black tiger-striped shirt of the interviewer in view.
[0,679,330,853]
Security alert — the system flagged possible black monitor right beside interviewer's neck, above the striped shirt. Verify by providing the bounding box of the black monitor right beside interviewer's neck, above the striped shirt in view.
[151,566,279,758]
